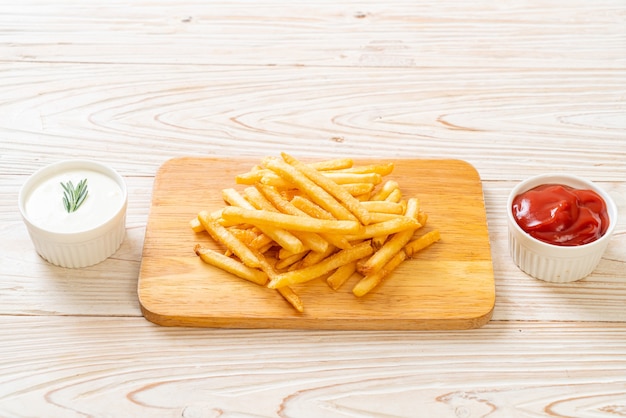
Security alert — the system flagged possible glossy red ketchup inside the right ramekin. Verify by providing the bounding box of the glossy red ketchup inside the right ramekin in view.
[512,184,609,246]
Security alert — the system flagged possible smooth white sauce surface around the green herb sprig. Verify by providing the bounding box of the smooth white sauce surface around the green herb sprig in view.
[24,169,123,233]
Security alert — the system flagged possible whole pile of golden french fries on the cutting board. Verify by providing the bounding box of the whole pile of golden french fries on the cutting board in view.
[190,153,440,312]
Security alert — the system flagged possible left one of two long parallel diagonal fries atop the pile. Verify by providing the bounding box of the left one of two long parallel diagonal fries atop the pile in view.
[263,157,357,220]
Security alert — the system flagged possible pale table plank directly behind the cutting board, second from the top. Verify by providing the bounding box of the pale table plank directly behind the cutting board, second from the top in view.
[0,64,626,181]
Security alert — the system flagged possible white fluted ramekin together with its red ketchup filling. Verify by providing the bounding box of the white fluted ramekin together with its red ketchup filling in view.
[507,174,617,283]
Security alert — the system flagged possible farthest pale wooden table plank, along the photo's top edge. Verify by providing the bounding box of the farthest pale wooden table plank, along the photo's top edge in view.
[0,0,626,69]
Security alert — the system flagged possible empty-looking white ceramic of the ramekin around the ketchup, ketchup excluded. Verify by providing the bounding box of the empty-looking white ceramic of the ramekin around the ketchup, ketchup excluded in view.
[507,174,617,283]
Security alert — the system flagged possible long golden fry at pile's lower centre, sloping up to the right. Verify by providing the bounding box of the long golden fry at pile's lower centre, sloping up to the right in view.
[267,241,374,289]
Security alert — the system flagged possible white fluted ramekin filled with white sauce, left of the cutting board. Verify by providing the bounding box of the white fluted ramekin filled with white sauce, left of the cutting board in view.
[18,160,127,268]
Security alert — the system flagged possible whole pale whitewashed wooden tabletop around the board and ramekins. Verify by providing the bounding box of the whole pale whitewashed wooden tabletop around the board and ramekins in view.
[0,0,626,418]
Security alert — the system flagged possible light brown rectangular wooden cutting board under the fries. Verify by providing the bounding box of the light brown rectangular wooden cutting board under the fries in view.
[138,157,495,330]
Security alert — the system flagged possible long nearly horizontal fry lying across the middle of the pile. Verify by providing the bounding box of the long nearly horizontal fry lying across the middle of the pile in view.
[222,206,360,235]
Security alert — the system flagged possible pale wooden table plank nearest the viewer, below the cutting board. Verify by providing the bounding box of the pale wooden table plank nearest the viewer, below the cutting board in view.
[0,317,626,418]
